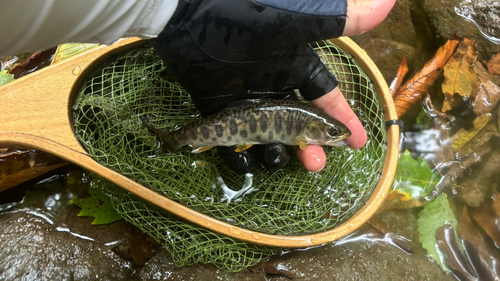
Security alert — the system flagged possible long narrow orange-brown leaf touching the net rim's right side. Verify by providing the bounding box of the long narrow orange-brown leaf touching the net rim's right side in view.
[394,36,460,118]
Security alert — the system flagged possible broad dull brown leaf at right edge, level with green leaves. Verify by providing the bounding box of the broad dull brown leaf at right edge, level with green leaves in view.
[455,150,500,207]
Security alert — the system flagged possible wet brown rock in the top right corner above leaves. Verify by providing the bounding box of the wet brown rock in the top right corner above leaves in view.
[417,0,500,60]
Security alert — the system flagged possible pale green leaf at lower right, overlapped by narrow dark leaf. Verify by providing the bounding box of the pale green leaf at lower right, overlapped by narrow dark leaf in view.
[417,193,459,272]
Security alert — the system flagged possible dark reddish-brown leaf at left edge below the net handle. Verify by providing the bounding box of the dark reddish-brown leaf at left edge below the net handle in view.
[0,150,66,192]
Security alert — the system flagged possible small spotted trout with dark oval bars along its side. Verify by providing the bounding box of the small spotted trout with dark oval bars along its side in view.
[142,99,351,153]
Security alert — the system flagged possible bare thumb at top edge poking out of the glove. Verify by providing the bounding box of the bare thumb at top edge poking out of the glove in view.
[342,0,396,36]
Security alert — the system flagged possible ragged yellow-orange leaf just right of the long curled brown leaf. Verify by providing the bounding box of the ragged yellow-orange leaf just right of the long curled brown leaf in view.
[441,38,477,112]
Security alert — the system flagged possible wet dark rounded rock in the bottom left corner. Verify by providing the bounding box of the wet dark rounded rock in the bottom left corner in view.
[0,212,133,280]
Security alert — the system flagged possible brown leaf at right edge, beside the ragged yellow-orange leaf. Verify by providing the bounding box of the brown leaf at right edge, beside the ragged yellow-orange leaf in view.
[472,62,500,116]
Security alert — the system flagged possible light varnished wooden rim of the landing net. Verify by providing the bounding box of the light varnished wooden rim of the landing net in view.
[0,38,399,248]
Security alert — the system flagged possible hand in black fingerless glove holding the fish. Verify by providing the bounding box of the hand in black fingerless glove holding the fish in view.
[148,0,395,172]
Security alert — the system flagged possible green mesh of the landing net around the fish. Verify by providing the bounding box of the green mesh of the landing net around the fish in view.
[73,41,386,271]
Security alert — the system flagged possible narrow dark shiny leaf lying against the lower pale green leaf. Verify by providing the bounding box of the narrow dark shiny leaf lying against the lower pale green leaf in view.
[436,224,477,280]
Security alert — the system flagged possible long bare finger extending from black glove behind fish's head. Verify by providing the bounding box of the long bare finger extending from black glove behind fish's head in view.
[311,87,368,149]
